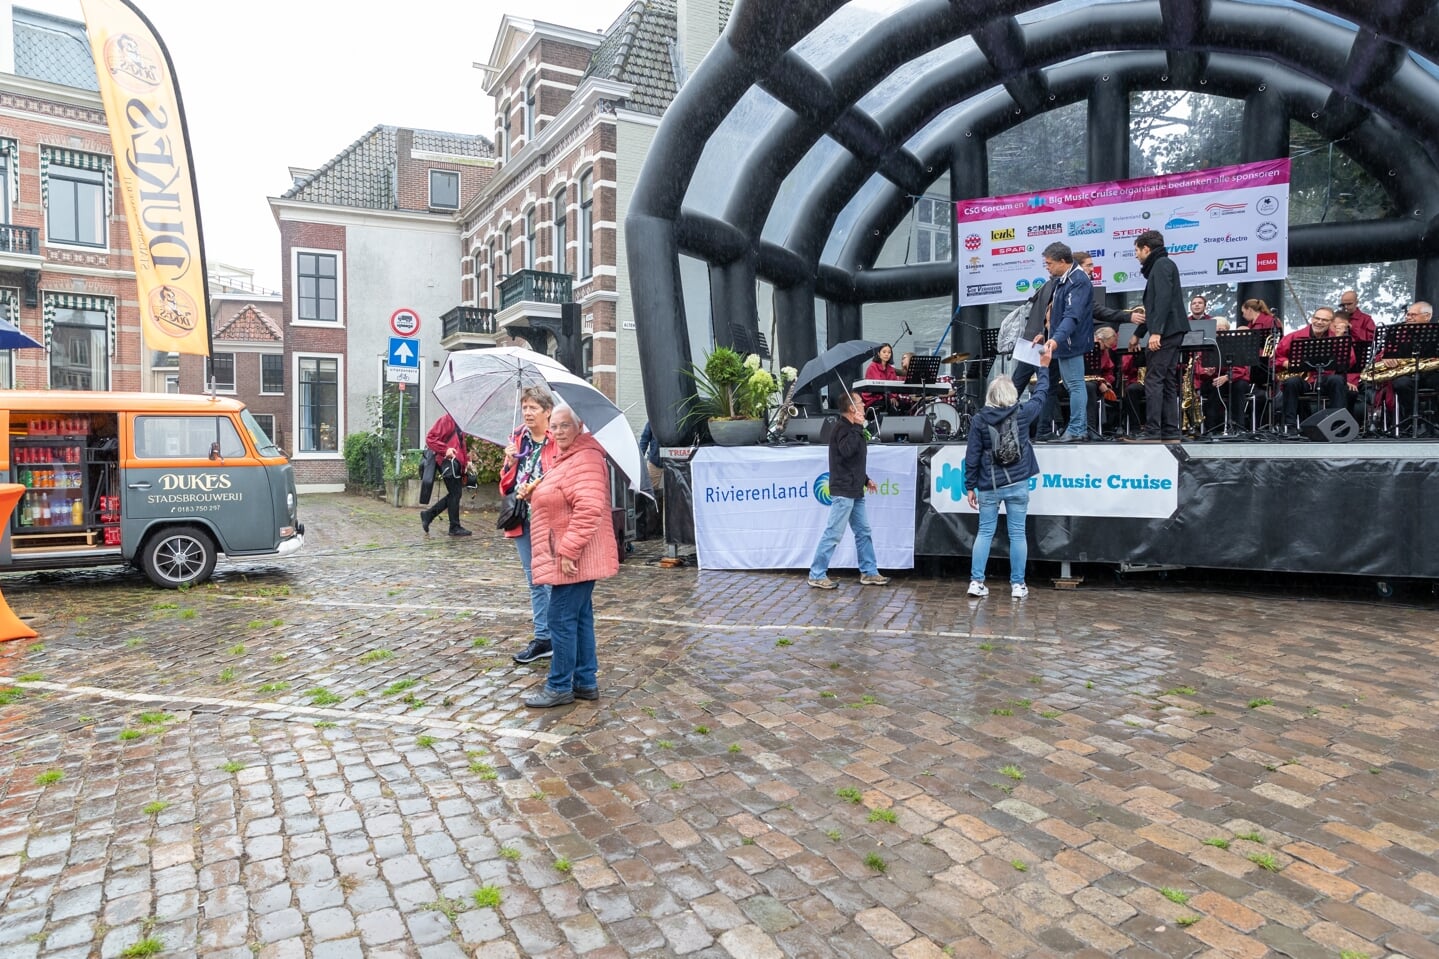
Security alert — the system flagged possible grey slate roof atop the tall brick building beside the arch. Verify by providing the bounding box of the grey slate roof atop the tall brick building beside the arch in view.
[586,0,734,115]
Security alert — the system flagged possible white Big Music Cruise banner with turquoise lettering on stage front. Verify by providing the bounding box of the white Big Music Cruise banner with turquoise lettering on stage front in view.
[930,444,1179,520]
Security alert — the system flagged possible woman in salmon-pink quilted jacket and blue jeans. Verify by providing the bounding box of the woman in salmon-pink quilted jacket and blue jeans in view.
[525,406,620,708]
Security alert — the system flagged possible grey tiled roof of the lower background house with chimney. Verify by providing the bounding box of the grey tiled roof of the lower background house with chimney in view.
[282,124,495,210]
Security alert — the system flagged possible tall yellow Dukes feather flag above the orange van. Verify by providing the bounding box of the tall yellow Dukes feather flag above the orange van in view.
[81,0,210,356]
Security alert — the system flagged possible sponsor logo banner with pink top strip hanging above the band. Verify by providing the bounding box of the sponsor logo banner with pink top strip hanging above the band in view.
[955,158,1289,305]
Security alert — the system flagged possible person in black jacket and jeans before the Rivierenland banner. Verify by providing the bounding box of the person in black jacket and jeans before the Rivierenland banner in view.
[810,393,889,589]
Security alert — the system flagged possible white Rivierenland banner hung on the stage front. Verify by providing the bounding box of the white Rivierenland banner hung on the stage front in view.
[691,446,921,569]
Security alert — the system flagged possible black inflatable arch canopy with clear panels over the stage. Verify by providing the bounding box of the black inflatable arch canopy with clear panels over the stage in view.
[625,0,1439,445]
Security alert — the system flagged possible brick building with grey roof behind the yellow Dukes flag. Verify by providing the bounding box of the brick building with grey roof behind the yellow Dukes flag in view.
[0,4,148,390]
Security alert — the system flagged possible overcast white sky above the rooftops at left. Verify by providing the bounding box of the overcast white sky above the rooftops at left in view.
[35,0,627,289]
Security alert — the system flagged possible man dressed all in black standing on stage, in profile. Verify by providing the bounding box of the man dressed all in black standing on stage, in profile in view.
[1128,230,1189,444]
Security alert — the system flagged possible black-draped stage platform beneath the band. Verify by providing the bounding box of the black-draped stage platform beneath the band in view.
[665,439,1439,579]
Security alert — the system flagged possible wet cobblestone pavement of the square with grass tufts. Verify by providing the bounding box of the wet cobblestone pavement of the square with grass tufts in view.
[0,495,1439,959]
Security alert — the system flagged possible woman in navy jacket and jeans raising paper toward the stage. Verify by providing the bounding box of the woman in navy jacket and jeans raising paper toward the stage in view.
[964,350,1053,599]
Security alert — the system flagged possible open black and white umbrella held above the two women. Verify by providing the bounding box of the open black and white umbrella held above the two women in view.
[435,347,645,492]
